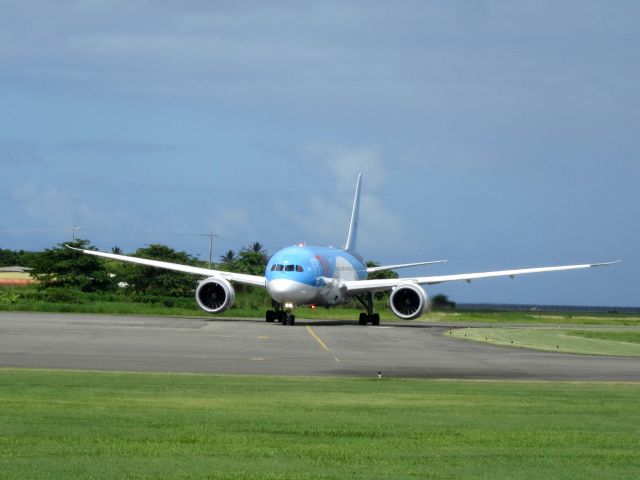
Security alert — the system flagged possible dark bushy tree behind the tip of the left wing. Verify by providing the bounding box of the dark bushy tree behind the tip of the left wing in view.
[31,239,114,292]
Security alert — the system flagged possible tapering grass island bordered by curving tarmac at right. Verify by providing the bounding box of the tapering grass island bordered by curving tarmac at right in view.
[447,327,640,357]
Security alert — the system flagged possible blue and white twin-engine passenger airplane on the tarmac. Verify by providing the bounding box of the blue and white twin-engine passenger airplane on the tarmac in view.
[67,173,620,325]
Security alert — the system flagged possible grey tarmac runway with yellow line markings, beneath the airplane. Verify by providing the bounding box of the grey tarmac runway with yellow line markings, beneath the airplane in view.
[0,312,640,381]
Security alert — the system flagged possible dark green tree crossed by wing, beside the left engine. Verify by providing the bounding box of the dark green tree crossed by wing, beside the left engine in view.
[118,244,196,297]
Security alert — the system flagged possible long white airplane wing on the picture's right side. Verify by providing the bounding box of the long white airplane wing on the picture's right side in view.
[340,260,620,295]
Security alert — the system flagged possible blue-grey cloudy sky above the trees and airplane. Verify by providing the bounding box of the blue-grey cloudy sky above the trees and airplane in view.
[0,0,640,306]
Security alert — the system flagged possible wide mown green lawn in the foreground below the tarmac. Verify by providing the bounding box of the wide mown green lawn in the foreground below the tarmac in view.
[0,369,640,479]
